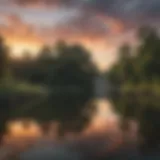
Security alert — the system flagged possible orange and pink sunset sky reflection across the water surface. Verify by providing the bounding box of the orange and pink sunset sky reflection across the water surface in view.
[0,98,158,159]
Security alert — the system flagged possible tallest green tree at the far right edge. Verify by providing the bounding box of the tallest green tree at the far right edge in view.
[138,28,160,82]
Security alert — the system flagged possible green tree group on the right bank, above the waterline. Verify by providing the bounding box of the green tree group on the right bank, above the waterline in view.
[109,27,160,84]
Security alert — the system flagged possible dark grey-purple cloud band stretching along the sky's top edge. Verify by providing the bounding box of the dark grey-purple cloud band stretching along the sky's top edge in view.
[6,0,160,29]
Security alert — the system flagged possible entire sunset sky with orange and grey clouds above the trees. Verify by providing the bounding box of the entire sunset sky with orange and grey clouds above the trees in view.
[0,0,160,69]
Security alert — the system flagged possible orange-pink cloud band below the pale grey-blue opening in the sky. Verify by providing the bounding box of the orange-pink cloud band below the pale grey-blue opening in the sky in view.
[0,7,125,44]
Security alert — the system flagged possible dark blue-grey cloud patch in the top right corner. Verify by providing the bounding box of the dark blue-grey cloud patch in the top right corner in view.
[88,0,160,19]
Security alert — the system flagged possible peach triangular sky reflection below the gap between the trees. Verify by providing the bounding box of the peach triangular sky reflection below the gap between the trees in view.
[85,99,120,133]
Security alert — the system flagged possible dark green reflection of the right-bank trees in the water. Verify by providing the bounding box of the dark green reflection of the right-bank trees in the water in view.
[112,93,160,152]
